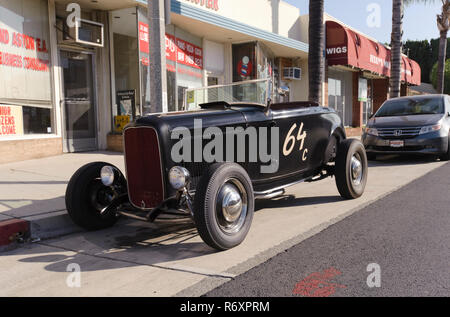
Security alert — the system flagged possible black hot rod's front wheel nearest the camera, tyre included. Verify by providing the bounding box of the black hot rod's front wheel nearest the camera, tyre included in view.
[194,163,255,251]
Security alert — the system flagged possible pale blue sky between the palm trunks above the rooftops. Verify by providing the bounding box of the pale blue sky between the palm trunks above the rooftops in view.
[284,0,442,43]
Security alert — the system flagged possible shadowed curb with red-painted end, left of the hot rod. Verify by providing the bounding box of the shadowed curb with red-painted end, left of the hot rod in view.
[0,211,82,252]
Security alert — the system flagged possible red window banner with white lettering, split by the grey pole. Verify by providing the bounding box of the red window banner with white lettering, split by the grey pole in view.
[139,22,203,69]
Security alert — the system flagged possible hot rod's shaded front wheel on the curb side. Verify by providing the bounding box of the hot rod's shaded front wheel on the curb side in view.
[66,162,126,231]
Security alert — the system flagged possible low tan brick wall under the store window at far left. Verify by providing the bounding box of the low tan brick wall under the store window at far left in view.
[0,138,62,164]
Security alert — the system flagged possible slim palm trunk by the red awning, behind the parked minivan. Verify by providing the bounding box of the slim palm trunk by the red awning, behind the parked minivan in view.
[389,0,403,98]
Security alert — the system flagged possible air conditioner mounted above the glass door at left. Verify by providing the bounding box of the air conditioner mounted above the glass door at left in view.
[57,19,104,47]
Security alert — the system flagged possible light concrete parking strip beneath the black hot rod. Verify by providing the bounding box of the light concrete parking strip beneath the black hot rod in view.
[0,153,444,296]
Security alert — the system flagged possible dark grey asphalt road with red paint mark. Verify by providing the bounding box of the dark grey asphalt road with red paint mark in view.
[206,160,450,297]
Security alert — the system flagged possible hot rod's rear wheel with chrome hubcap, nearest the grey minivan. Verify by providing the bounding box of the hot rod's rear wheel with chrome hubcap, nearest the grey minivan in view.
[335,139,368,199]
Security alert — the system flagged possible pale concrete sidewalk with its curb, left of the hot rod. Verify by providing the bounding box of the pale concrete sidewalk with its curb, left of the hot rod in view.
[0,152,124,251]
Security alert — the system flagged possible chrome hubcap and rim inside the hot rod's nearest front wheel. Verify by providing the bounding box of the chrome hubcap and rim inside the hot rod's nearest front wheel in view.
[216,178,247,234]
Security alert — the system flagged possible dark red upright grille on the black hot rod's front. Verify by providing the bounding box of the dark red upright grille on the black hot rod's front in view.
[124,127,164,210]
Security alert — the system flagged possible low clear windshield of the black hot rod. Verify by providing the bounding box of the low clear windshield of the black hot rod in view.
[185,79,272,110]
